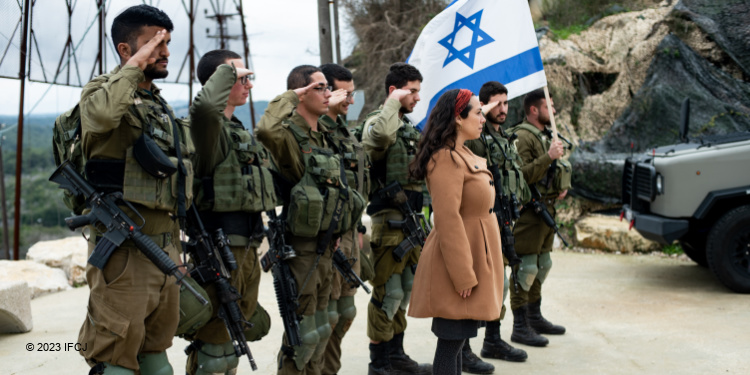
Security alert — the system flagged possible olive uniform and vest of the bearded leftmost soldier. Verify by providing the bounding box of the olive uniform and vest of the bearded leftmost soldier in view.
[78,66,193,373]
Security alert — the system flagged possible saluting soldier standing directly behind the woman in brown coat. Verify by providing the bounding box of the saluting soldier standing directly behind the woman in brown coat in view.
[462,81,531,374]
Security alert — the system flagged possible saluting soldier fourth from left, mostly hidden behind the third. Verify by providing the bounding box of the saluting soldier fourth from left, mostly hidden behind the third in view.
[320,64,370,375]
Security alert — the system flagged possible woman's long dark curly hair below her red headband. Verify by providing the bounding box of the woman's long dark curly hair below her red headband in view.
[409,89,472,180]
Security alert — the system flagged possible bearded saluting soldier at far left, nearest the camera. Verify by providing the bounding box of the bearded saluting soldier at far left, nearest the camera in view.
[78,5,193,374]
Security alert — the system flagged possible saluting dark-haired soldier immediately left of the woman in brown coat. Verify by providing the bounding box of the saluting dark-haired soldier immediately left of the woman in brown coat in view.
[362,63,432,375]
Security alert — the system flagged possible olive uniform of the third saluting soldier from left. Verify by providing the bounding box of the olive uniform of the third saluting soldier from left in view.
[257,90,364,374]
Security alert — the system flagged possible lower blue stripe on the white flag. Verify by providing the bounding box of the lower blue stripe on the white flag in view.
[417,47,544,131]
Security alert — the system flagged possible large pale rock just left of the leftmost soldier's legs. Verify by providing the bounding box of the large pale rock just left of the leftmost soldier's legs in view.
[26,236,88,285]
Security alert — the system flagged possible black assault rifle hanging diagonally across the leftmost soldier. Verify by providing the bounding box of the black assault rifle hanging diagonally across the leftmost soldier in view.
[49,161,208,305]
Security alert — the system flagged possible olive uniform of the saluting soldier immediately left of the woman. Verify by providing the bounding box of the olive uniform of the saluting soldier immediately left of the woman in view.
[362,99,423,342]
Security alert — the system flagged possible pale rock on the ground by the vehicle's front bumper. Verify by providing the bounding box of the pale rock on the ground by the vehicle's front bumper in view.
[575,214,662,253]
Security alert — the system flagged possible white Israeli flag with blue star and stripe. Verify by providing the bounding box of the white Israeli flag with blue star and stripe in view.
[406,0,547,130]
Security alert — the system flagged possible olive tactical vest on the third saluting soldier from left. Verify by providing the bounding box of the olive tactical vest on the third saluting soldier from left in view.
[285,121,365,237]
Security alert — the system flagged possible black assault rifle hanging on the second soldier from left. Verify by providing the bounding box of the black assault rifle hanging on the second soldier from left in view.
[185,205,258,371]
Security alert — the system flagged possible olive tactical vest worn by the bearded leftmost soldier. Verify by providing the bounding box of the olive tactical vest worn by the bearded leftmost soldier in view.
[85,92,195,212]
